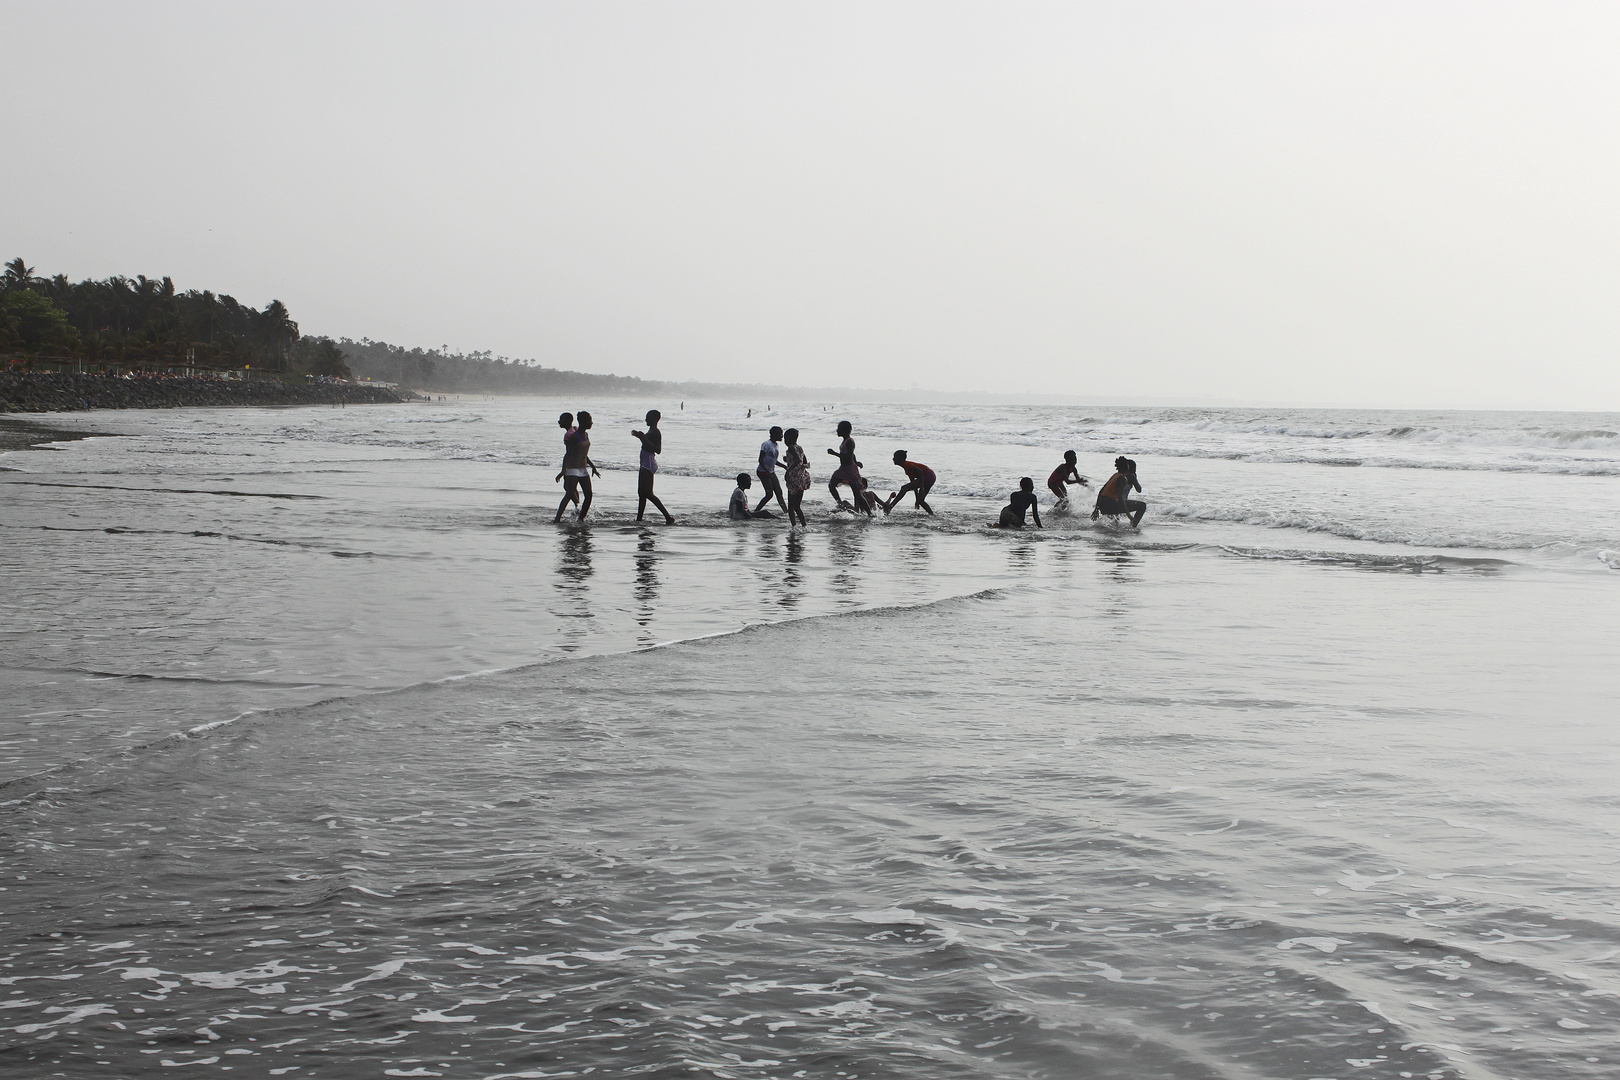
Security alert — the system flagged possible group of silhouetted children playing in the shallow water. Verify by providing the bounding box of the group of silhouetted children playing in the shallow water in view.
[554,408,1147,528]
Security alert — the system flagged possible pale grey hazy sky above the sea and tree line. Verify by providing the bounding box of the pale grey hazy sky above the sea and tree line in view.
[0,0,1620,410]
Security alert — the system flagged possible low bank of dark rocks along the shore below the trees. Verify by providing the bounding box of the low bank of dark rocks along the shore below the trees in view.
[0,372,405,413]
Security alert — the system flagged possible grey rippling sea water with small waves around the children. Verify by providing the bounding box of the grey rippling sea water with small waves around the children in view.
[0,398,1620,1080]
